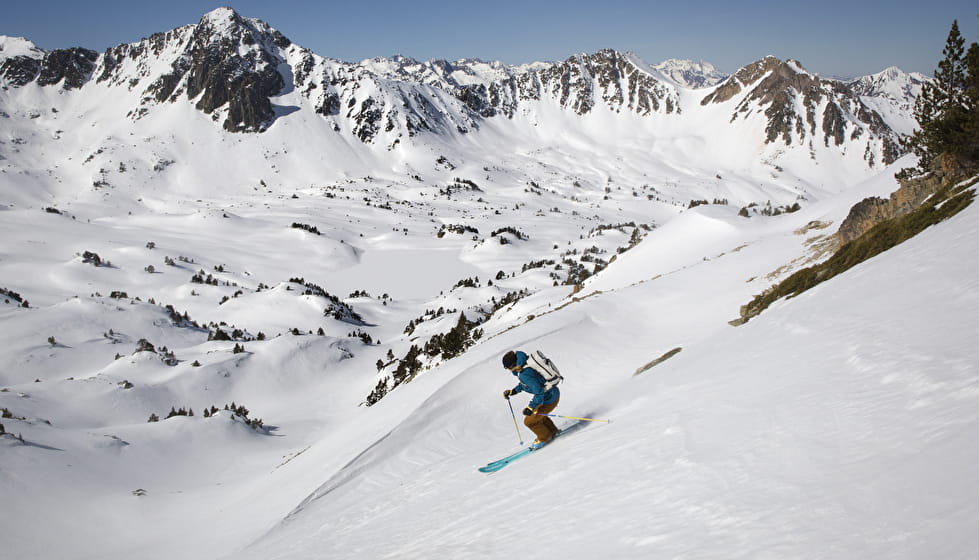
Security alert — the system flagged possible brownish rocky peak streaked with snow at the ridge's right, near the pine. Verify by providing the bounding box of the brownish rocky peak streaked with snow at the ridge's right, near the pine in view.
[701,57,903,165]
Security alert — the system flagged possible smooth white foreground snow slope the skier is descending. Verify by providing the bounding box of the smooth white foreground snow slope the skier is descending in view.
[239,172,979,558]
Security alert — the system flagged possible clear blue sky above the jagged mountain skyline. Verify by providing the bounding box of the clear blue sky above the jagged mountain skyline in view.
[0,0,979,77]
